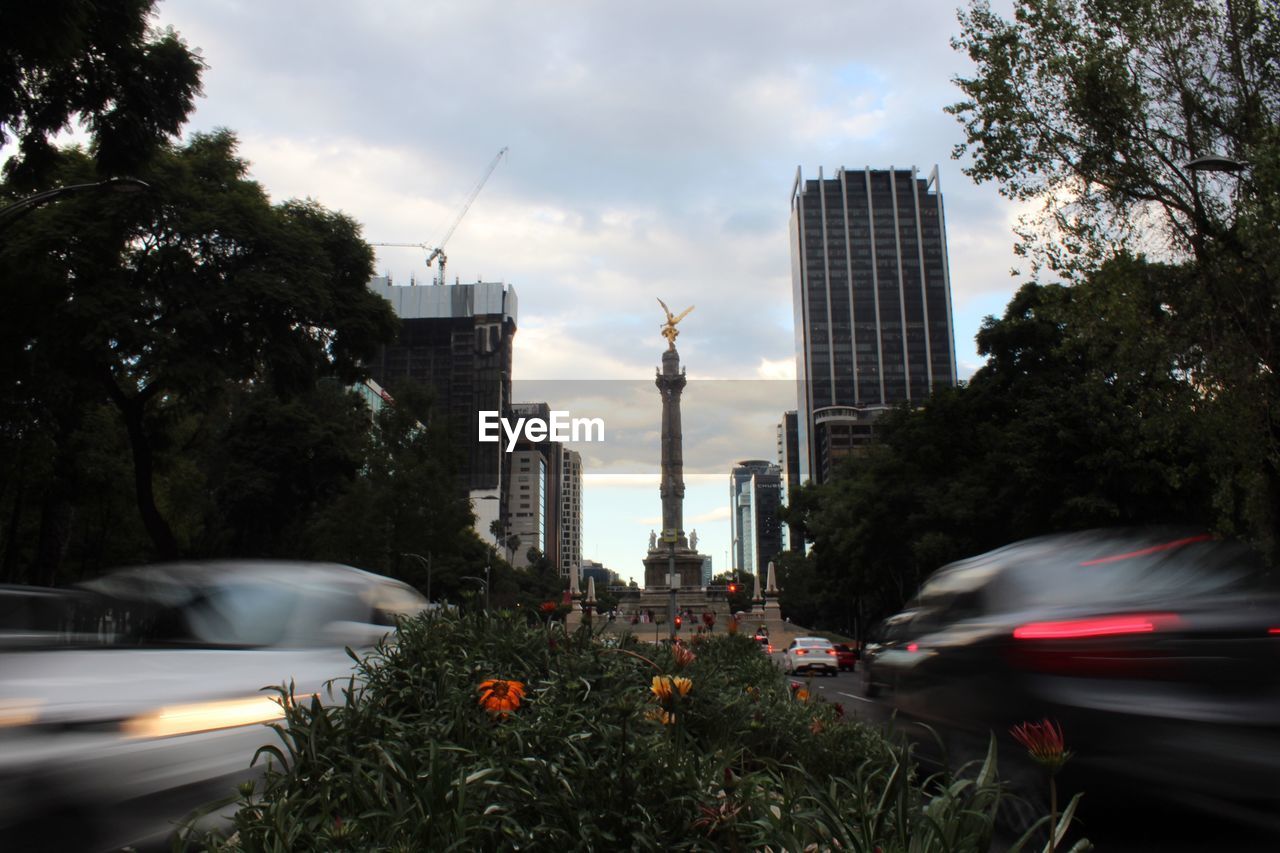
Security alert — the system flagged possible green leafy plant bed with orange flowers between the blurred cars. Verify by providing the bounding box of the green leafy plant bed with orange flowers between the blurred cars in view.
[192,615,1080,853]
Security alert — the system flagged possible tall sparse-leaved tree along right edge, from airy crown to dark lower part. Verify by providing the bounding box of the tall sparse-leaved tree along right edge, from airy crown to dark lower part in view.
[950,0,1280,557]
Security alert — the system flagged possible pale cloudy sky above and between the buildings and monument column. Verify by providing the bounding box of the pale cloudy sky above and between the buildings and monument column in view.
[156,0,1018,576]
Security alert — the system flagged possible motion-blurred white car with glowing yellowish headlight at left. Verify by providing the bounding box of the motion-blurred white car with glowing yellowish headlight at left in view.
[0,562,426,850]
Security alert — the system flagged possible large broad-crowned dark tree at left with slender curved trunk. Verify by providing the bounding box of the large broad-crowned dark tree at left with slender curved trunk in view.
[0,131,396,568]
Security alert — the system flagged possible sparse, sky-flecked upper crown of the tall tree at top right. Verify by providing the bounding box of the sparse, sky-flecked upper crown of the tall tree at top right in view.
[948,0,1280,273]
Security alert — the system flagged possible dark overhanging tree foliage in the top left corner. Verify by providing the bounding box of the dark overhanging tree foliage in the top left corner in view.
[0,0,204,180]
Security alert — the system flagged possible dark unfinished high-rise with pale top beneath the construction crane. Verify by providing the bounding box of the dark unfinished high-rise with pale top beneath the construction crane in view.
[369,277,517,540]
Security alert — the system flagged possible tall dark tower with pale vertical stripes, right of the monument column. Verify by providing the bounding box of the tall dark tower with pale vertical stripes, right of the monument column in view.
[791,168,956,483]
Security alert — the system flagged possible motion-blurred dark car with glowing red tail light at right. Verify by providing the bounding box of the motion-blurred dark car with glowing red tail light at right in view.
[868,529,1280,822]
